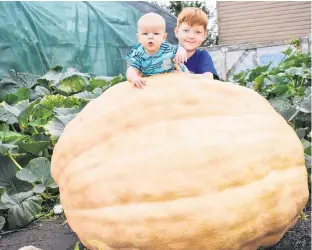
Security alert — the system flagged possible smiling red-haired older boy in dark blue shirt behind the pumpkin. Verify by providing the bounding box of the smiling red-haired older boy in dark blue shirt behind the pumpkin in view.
[175,7,219,79]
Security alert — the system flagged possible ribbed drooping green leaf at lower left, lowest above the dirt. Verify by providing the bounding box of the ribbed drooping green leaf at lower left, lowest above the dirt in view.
[0,191,42,229]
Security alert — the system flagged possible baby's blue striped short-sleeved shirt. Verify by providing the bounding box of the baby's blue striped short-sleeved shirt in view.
[125,42,178,76]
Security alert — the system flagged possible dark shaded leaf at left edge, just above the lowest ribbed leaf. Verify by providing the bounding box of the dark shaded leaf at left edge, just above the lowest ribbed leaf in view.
[0,156,33,194]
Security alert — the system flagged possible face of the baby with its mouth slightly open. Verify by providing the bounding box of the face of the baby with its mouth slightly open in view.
[137,24,167,55]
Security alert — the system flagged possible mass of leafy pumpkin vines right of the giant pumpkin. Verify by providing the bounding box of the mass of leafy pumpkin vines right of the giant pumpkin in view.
[233,39,311,188]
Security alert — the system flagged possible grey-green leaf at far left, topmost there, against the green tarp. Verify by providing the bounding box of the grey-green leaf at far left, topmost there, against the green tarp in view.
[0,69,39,101]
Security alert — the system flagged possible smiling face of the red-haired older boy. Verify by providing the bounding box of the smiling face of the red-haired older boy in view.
[175,23,207,51]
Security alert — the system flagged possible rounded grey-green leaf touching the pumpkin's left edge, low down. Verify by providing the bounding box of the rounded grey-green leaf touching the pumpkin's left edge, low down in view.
[16,157,57,192]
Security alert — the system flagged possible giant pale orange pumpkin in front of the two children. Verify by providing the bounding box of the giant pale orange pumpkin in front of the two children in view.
[51,73,309,250]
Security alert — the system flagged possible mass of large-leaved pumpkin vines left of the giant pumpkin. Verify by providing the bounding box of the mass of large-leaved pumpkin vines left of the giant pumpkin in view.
[0,66,125,230]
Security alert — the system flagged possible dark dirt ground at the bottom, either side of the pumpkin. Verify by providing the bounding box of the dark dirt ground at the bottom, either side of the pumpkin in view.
[0,208,311,250]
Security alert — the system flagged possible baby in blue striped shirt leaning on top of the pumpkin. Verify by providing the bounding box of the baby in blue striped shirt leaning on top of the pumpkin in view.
[126,13,187,88]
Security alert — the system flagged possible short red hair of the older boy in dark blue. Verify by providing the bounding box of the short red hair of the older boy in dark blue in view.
[177,7,208,30]
